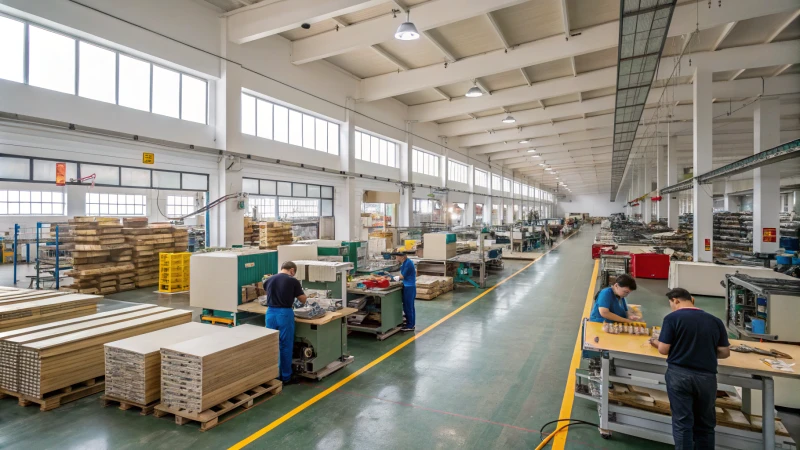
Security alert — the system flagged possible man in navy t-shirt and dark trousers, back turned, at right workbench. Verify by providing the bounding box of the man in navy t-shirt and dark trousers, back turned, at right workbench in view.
[650,288,731,450]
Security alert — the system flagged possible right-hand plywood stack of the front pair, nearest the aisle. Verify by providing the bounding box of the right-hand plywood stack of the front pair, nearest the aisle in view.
[161,325,278,414]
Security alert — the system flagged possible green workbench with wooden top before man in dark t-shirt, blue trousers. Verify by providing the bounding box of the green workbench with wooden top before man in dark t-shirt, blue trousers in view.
[237,301,358,380]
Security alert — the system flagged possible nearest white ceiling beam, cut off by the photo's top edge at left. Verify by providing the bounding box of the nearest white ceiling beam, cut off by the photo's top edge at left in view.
[227,0,383,44]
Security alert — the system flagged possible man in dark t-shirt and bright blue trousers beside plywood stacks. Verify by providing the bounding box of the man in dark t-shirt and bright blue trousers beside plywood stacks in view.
[264,261,306,384]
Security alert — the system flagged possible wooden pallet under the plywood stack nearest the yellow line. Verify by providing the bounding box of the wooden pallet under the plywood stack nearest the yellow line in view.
[153,380,283,431]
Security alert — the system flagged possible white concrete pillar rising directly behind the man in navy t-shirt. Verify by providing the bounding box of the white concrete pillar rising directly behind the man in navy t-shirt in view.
[692,67,714,262]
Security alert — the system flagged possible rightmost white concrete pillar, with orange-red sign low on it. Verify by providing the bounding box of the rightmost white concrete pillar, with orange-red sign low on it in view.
[753,98,781,253]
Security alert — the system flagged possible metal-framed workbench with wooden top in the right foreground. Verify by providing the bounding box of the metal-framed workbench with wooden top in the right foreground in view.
[575,321,800,450]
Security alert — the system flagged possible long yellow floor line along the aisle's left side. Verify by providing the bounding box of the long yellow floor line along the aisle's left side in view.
[229,233,580,450]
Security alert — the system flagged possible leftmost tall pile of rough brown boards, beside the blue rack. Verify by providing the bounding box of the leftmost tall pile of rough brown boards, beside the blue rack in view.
[63,217,133,294]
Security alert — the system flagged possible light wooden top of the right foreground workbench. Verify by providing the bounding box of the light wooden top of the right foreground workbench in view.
[583,322,800,379]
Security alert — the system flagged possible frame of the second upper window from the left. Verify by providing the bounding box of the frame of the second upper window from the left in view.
[239,90,342,156]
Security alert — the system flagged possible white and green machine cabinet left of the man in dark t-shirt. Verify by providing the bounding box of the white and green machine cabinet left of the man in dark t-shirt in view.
[189,249,278,326]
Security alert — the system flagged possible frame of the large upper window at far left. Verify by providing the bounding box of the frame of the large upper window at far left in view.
[0,13,209,125]
